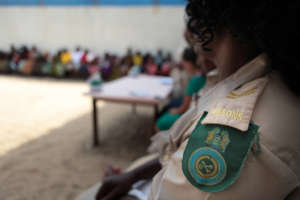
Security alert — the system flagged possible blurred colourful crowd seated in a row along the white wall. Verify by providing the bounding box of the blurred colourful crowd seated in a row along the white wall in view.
[0,45,176,80]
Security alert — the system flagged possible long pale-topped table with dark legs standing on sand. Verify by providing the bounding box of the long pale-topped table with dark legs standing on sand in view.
[85,75,173,147]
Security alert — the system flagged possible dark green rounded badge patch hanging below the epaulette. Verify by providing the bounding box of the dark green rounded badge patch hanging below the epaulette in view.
[182,112,259,193]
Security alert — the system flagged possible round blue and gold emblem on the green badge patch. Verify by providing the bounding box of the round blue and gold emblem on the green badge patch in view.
[188,147,227,186]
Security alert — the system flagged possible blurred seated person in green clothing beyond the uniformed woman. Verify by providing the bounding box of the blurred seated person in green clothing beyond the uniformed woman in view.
[156,48,206,131]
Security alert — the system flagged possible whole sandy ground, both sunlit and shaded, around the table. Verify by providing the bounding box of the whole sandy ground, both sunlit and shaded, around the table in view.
[0,75,153,200]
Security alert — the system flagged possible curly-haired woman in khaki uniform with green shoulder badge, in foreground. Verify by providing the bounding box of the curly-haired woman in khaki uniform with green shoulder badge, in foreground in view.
[96,0,300,200]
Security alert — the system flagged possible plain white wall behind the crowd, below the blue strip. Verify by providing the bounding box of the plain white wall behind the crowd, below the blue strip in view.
[0,6,184,54]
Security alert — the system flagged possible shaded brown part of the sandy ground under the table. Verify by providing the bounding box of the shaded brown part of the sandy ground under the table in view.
[0,104,153,200]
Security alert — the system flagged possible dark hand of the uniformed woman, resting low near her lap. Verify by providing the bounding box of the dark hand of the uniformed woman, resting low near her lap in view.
[96,174,135,200]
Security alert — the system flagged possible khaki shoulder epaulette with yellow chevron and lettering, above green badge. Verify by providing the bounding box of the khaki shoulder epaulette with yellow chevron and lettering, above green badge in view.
[199,54,268,131]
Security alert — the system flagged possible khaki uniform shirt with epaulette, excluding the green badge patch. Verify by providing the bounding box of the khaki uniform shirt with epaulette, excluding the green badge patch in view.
[148,55,300,200]
